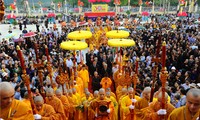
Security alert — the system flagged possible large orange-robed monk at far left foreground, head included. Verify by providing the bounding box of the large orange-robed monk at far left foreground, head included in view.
[0,82,34,120]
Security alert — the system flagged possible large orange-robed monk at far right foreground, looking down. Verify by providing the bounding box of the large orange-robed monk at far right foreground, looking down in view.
[168,88,200,120]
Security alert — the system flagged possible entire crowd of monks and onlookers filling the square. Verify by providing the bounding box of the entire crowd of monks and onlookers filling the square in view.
[0,14,200,120]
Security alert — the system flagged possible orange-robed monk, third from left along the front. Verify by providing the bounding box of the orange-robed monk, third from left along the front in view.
[46,88,66,120]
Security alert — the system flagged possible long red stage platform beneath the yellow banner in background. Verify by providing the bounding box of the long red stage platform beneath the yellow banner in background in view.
[84,12,115,17]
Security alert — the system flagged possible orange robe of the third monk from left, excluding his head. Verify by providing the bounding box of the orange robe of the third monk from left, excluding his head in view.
[46,96,66,120]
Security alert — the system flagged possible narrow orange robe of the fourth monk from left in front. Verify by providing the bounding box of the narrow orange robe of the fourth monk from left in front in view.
[60,95,70,119]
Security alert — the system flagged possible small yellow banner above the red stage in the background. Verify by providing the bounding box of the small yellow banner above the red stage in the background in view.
[92,4,108,12]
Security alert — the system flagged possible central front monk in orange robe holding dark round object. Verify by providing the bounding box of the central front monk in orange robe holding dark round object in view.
[91,88,114,120]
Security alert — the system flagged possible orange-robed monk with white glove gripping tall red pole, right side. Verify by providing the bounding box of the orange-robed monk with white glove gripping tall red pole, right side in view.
[142,92,175,120]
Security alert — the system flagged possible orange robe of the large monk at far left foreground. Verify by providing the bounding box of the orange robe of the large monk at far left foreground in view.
[0,99,34,120]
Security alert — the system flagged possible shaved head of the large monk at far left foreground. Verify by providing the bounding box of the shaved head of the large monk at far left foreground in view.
[0,82,15,109]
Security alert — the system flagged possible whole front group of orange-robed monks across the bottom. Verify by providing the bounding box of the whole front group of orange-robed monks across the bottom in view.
[0,82,200,120]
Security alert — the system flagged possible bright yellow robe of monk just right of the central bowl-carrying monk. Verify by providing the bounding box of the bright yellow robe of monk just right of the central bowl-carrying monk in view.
[121,95,140,120]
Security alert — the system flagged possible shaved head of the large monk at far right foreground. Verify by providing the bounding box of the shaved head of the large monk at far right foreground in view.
[186,88,200,114]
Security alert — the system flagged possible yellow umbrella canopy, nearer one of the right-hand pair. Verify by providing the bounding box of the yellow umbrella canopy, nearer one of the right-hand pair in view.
[108,39,135,47]
